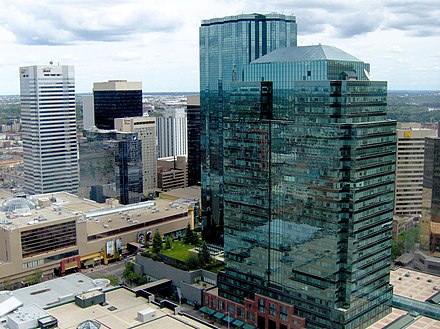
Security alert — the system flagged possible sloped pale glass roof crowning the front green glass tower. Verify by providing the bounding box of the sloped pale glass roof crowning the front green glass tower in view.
[252,45,362,64]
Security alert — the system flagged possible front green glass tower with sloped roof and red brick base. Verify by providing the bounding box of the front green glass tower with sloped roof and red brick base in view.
[204,45,396,329]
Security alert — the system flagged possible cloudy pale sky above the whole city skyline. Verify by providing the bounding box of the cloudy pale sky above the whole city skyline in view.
[0,0,440,95]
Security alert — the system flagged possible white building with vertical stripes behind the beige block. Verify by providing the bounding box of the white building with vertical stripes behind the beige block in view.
[156,108,188,158]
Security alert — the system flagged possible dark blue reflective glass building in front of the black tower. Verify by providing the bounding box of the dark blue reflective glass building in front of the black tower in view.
[78,130,143,204]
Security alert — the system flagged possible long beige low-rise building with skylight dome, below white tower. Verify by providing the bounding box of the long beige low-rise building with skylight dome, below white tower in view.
[0,192,194,290]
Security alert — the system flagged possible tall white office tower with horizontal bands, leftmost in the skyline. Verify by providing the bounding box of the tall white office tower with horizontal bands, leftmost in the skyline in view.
[20,65,78,194]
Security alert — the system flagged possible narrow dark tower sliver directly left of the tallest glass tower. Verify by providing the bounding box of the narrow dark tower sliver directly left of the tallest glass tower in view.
[186,95,201,186]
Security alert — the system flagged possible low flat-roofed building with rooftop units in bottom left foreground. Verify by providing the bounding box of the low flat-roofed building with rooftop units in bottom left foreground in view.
[0,273,212,329]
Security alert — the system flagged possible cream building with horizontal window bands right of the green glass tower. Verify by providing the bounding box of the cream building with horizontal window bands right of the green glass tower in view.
[394,122,437,216]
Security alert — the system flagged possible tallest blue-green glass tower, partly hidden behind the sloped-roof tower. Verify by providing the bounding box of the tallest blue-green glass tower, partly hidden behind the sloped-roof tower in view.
[200,14,297,240]
